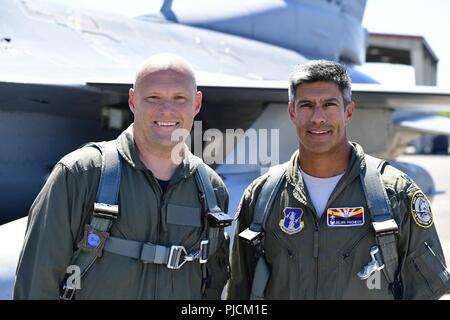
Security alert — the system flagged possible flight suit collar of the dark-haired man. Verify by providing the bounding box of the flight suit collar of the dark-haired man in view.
[286,142,366,205]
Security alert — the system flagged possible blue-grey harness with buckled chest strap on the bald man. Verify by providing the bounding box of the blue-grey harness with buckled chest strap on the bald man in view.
[60,146,227,300]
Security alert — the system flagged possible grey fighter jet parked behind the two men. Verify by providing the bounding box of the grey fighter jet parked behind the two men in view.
[0,0,450,298]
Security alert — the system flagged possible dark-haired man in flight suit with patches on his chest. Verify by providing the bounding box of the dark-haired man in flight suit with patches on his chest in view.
[228,60,450,299]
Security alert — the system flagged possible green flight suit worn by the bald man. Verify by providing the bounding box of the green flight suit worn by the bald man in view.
[14,126,229,299]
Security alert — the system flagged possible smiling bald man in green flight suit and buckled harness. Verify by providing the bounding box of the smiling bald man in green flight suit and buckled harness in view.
[14,54,229,300]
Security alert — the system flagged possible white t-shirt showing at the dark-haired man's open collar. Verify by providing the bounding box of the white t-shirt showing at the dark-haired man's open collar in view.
[300,168,345,219]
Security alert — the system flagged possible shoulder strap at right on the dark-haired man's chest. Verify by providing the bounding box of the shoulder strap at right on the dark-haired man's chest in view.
[360,155,398,296]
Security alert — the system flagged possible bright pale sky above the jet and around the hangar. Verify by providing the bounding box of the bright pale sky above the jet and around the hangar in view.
[55,0,450,88]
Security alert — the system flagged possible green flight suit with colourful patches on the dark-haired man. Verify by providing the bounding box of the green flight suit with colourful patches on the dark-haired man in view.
[227,143,449,299]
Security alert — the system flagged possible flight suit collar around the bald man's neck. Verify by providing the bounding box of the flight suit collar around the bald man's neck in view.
[117,124,198,180]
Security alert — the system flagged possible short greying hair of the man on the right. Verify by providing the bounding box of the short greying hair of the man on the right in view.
[289,60,352,106]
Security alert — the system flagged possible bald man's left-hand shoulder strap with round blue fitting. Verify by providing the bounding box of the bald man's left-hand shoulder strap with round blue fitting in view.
[61,140,121,300]
